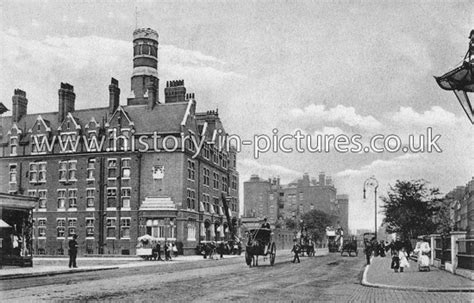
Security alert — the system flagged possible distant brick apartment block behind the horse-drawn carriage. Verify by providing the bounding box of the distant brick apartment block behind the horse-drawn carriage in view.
[244,173,349,231]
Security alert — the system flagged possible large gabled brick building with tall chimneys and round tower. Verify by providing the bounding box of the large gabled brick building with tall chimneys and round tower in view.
[0,29,239,255]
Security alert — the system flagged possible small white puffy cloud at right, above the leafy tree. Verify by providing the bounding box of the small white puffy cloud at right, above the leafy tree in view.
[391,106,458,126]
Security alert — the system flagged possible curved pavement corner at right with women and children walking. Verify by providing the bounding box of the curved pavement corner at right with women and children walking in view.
[362,257,474,292]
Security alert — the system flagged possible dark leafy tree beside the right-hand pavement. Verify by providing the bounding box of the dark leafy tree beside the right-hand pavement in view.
[382,180,449,239]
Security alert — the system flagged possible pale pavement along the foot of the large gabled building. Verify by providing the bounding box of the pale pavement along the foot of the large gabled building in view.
[0,255,243,281]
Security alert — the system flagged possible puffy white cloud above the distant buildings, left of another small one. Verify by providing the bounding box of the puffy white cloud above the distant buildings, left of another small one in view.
[290,103,382,129]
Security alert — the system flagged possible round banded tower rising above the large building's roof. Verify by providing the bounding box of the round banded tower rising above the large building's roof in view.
[127,28,159,108]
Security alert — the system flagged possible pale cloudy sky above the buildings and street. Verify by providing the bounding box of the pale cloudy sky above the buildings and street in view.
[0,0,474,230]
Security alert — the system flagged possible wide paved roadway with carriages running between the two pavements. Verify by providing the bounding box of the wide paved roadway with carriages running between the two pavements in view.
[0,253,473,303]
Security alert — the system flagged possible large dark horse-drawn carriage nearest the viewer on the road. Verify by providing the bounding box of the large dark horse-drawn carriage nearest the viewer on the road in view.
[245,228,276,266]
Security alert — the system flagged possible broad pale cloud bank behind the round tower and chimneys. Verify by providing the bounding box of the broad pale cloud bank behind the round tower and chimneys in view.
[0,29,242,113]
